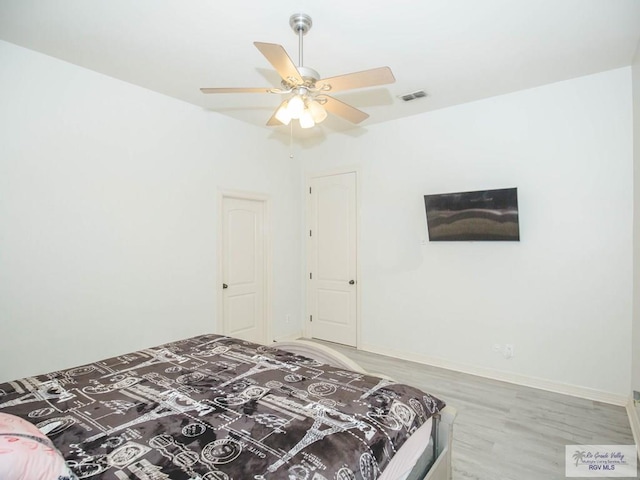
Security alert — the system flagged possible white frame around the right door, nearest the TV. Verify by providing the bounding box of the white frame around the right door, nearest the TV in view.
[302,165,364,350]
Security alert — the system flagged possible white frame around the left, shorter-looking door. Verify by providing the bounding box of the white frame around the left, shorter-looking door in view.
[216,188,273,343]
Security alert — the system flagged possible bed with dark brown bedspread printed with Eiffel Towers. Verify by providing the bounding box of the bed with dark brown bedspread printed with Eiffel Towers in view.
[0,334,455,480]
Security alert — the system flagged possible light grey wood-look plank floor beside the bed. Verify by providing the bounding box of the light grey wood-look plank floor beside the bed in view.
[322,342,634,480]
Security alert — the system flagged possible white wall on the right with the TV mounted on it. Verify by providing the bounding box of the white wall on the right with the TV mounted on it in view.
[305,68,633,399]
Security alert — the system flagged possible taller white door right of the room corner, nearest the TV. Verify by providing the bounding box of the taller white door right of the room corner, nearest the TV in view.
[309,172,358,346]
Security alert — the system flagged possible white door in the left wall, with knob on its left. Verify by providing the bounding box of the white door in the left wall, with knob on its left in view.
[220,197,267,343]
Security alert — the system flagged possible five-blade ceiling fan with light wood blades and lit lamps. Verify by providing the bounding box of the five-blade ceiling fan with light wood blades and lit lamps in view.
[200,13,395,128]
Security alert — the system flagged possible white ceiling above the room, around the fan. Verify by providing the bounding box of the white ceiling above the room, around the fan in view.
[0,0,640,139]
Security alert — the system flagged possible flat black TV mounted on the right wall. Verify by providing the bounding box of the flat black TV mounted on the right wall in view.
[424,188,520,242]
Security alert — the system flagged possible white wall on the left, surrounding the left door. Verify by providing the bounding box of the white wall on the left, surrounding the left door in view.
[0,42,303,381]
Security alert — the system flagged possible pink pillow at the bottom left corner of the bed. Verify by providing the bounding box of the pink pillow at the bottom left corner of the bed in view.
[0,413,76,480]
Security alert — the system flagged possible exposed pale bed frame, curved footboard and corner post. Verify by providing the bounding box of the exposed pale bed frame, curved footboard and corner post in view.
[273,340,457,480]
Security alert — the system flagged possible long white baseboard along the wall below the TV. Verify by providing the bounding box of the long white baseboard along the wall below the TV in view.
[359,344,627,407]
